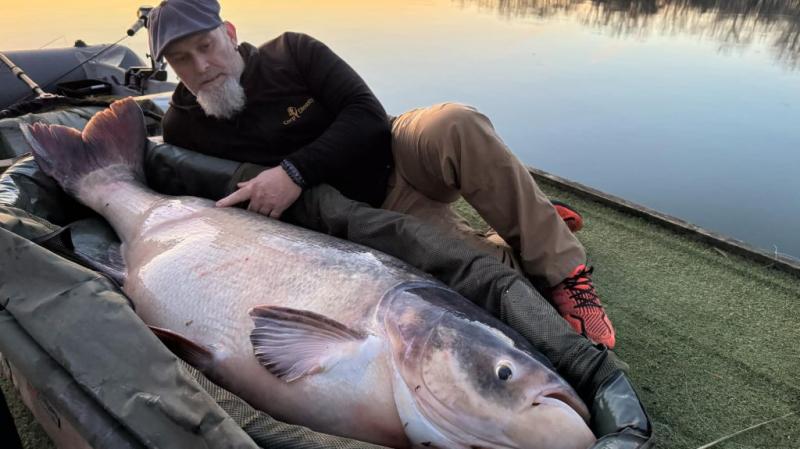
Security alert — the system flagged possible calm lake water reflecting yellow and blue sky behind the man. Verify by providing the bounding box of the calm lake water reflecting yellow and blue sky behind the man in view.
[0,0,800,257]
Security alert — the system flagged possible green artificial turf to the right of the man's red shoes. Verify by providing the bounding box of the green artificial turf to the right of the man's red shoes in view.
[468,179,800,449]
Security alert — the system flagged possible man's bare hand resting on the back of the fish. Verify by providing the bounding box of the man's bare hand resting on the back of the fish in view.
[217,167,303,218]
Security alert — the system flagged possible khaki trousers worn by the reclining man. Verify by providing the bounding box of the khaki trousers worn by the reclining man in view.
[381,103,586,286]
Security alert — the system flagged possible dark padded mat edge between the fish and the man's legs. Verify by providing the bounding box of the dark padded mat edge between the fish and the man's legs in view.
[284,185,627,404]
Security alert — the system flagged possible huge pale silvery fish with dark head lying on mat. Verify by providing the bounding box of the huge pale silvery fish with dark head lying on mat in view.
[24,99,595,449]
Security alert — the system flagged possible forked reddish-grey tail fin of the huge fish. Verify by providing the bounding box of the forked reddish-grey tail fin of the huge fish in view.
[22,98,146,193]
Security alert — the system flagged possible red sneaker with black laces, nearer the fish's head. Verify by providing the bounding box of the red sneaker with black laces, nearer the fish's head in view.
[551,265,616,348]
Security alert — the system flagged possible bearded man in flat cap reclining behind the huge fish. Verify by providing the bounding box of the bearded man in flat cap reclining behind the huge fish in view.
[148,0,615,347]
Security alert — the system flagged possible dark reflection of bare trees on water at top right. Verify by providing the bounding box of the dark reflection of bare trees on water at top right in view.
[454,0,800,69]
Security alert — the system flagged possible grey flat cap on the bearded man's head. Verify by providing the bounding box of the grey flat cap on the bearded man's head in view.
[147,0,222,60]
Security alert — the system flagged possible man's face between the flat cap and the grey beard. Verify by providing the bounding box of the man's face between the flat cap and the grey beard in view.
[164,23,244,95]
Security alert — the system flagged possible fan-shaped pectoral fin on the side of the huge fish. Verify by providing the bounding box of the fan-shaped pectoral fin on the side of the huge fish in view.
[250,306,366,382]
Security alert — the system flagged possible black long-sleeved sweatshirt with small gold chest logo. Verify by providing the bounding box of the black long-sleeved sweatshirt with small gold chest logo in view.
[163,33,392,206]
